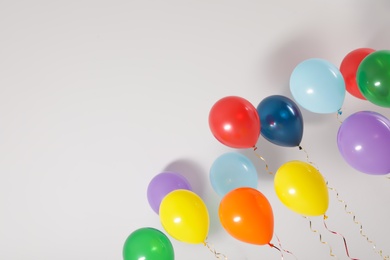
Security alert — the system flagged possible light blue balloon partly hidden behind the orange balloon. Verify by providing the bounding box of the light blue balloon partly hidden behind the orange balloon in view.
[210,152,258,197]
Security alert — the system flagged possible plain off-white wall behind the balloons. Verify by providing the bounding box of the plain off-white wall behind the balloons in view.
[0,0,390,260]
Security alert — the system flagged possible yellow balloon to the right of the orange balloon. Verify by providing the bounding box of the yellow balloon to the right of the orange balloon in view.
[274,161,329,216]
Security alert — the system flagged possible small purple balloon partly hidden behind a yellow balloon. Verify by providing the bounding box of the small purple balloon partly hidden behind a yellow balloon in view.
[147,172,192,214]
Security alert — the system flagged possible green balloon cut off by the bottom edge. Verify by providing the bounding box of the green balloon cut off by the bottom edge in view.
[123,228,175,260]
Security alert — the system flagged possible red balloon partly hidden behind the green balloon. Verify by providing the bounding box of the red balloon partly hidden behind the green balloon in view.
[340,48,375,100]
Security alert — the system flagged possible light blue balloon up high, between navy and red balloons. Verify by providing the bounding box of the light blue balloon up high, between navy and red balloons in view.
[290,59,346,114]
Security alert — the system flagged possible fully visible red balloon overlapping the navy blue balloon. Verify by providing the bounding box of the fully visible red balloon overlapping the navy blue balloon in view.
[209,96,260,148]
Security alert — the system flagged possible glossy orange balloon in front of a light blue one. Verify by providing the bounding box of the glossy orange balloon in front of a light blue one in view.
[219,187,274,245]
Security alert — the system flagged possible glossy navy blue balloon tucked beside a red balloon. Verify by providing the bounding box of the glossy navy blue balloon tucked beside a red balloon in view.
[257,95,303,147]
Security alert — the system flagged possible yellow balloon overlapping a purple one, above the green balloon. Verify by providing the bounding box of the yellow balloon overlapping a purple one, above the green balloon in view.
[159,190,209,244]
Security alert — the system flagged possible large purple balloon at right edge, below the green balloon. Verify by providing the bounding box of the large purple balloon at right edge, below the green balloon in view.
[337,111,390,175]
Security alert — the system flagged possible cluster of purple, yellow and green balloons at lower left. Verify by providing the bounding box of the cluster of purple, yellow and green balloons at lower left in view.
[123,172,209,260]
